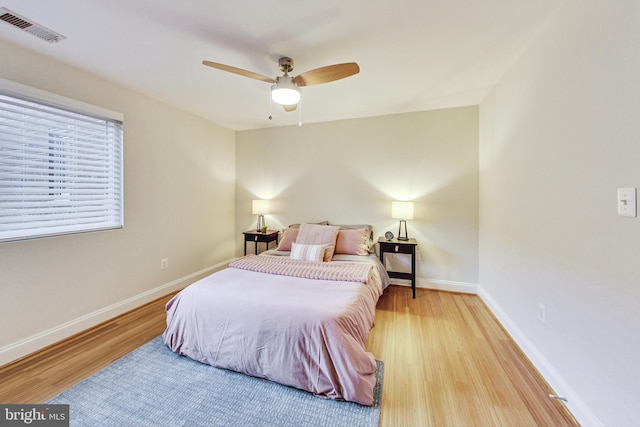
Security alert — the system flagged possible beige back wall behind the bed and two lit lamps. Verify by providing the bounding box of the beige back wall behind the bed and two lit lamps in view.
[236,107,478,291]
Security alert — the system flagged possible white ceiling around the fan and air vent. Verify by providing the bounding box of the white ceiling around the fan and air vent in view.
[0,0,563,130]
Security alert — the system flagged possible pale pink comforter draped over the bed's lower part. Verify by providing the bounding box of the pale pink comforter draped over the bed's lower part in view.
[163,257,383,405]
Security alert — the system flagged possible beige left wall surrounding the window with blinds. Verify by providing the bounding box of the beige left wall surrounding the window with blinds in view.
[0,40,235,364]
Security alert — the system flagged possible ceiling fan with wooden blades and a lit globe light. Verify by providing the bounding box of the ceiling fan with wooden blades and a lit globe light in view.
[202,56,360,111]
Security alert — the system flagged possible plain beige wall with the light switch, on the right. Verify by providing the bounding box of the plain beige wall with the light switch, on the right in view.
[480,0,640,426]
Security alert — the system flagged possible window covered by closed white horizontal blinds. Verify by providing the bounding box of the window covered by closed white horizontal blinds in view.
[0,80,123,242]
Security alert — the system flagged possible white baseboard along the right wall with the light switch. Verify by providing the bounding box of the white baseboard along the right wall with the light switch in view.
[478,286,604,427]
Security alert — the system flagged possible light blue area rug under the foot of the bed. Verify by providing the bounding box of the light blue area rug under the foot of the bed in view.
[47,337,384,427]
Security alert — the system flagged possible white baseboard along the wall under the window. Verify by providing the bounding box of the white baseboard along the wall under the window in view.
[0,261,229,366]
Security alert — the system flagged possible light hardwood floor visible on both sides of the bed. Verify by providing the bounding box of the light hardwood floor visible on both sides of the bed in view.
[0,286,577,426]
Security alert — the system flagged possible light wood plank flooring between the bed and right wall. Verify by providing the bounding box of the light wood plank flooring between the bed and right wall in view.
[367,286,578,426]
